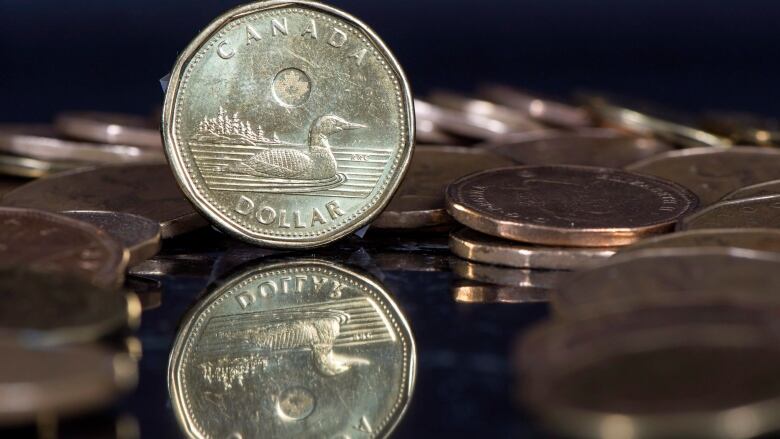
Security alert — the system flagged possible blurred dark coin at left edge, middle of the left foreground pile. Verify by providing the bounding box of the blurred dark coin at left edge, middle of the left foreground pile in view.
[0,269,141,346]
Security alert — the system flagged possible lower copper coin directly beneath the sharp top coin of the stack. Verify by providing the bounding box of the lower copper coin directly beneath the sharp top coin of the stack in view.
[450,227,620,270]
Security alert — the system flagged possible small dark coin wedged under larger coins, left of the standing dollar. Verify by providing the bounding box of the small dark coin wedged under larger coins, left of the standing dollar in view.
[64,210,162,267]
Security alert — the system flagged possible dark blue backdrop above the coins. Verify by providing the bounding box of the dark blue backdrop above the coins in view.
[0,0,780,121]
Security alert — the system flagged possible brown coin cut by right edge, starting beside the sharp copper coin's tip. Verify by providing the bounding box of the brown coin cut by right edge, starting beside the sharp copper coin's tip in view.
[677,195,780,230]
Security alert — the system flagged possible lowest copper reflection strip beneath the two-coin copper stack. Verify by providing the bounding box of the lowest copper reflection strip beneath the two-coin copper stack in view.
[452,280,550,303]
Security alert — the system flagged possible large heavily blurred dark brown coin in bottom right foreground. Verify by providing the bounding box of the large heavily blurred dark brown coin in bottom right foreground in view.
[515,307,780,439]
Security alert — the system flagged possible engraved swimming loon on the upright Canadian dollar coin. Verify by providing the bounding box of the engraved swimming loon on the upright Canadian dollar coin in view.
[227,115,365,180]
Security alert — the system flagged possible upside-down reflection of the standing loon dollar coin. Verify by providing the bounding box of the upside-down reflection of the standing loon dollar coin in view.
[168,260,416,438]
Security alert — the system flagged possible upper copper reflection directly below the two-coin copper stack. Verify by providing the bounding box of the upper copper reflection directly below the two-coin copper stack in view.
[450,258,571,289]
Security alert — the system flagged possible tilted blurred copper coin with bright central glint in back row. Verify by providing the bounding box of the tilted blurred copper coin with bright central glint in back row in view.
[478,84,593,128]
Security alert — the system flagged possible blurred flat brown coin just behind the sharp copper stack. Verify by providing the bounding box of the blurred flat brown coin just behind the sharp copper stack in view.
[481,128,672,168]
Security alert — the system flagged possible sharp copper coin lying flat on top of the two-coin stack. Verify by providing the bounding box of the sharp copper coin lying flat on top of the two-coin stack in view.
[446,166,697,247]
